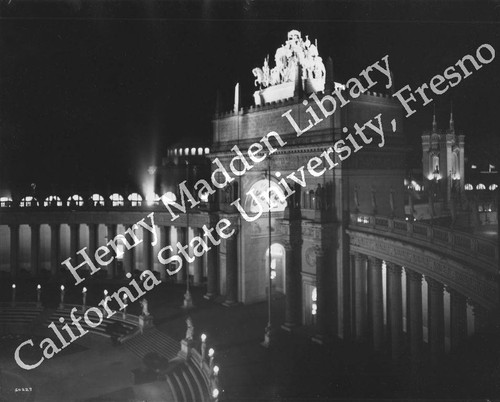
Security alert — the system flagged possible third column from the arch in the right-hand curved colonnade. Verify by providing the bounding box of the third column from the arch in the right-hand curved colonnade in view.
[386,262,403,360]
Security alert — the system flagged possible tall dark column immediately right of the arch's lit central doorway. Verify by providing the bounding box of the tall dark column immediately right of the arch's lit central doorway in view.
[283,243,301,330]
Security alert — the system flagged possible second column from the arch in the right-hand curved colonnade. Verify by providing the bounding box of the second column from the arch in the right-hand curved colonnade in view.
[368,257,384,350]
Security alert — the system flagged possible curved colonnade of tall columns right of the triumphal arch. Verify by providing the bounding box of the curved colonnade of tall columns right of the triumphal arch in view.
[350,253,488,361]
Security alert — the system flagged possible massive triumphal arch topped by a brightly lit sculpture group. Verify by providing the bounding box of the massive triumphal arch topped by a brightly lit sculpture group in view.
[211,30,404,338]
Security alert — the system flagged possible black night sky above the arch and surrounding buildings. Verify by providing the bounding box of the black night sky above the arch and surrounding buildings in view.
[0,0,500,195]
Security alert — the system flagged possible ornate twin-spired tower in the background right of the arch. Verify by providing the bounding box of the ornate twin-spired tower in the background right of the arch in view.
[422,108,465,207]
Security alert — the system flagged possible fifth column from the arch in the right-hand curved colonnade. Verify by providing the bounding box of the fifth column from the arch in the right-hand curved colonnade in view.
[425,277,444,363]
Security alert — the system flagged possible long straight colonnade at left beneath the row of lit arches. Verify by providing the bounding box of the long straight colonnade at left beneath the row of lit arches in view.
[2,223,218,295]
